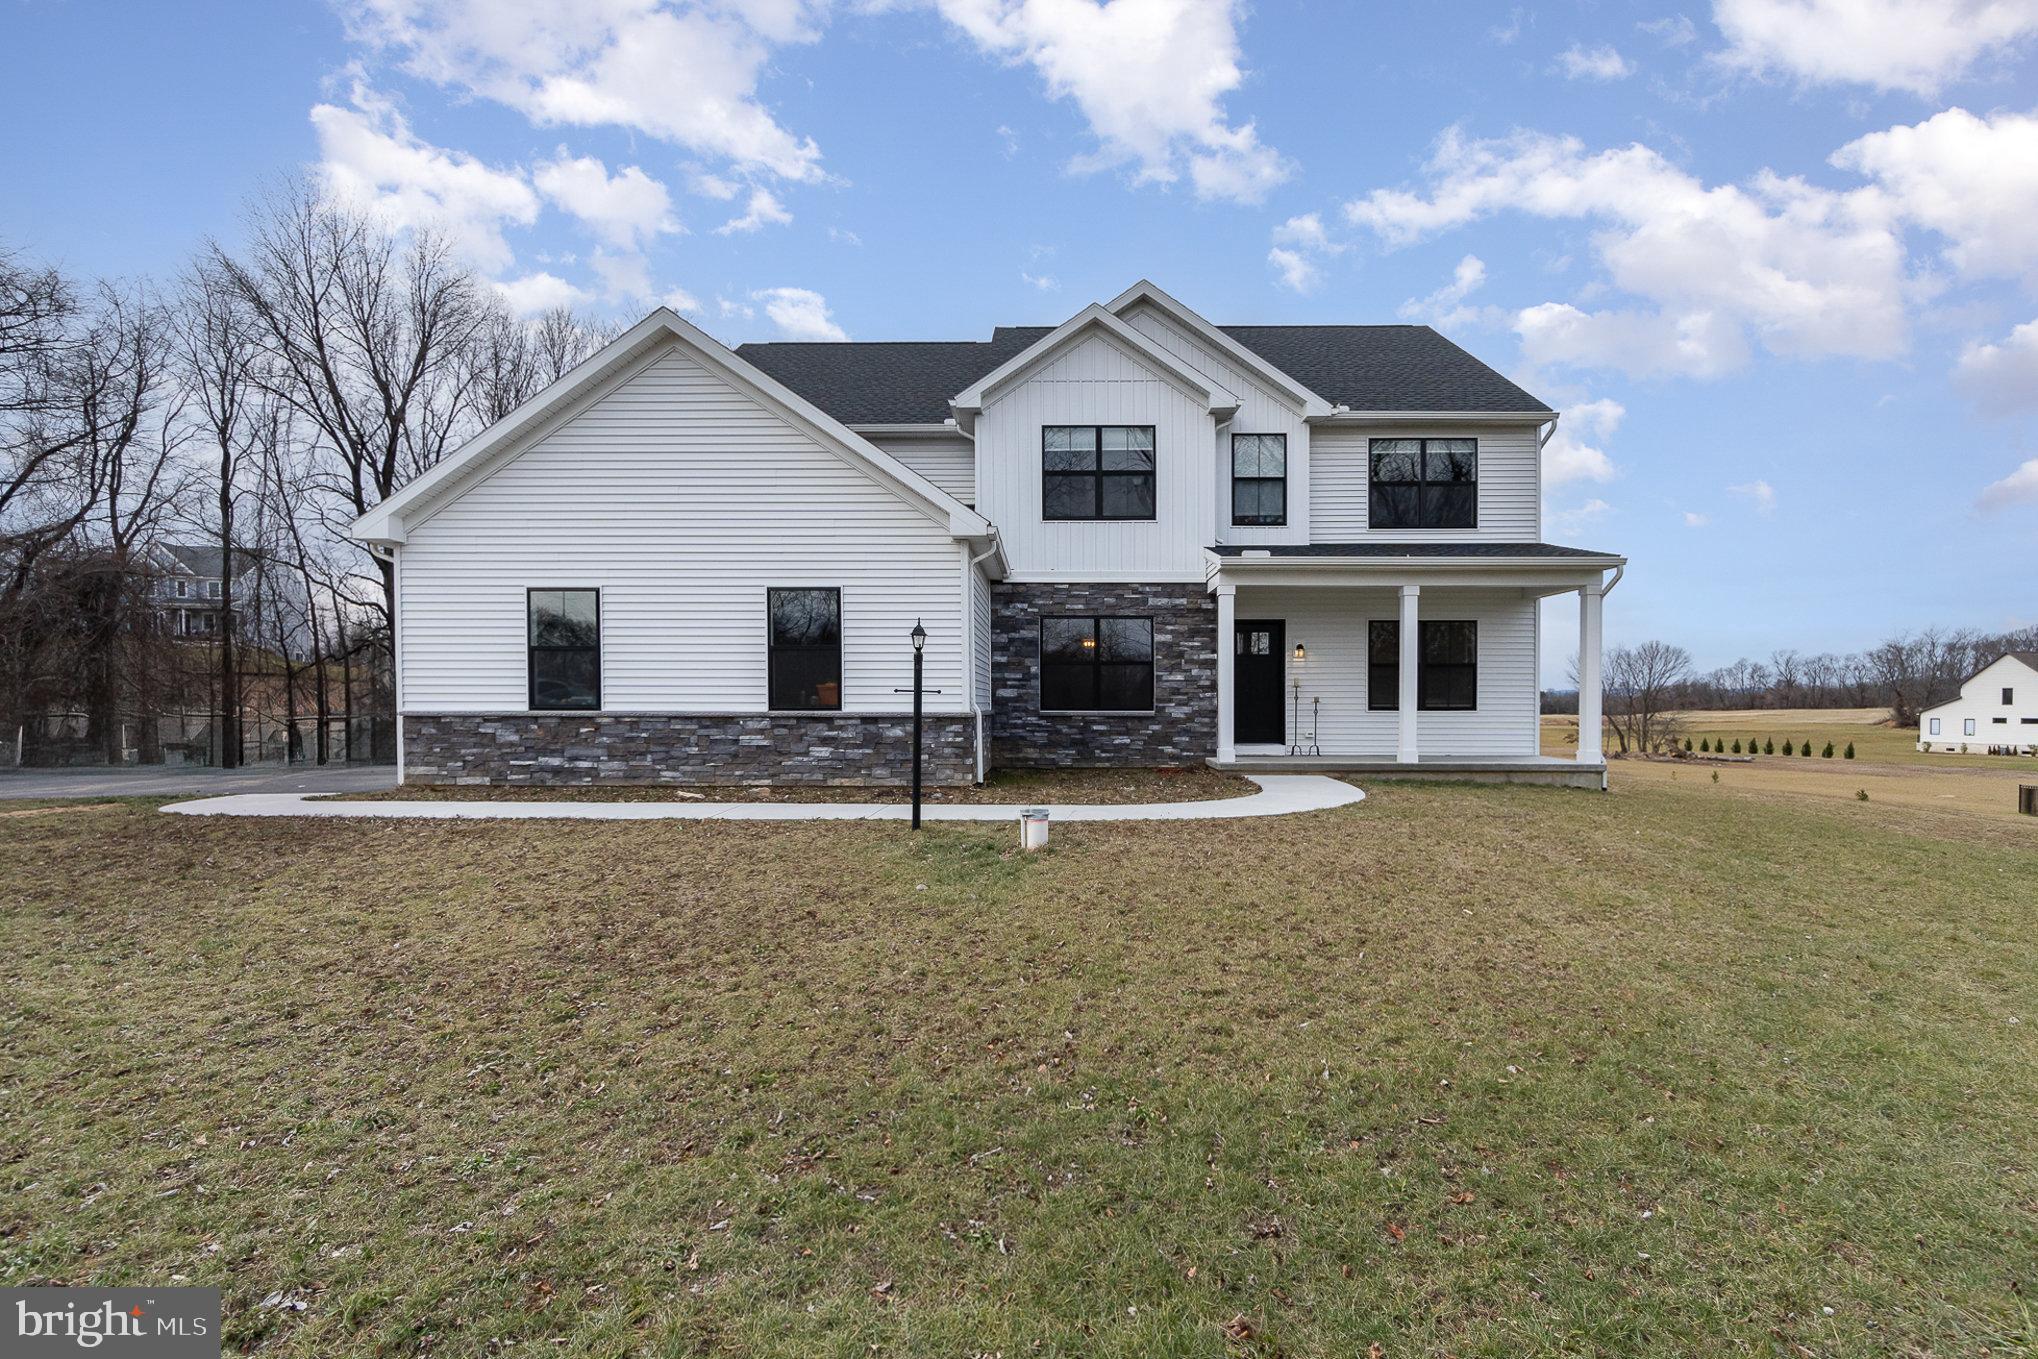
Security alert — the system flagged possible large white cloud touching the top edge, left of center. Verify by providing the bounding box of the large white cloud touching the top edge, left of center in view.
[342,0,823,181]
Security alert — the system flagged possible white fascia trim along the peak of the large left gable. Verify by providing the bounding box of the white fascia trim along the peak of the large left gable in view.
[348,308,990,546]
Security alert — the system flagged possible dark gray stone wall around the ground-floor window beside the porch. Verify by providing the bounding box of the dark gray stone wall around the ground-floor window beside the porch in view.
[990,585,1217,768]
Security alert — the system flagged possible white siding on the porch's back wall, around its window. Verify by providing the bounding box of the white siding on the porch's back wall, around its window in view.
[1235,585,1541,760]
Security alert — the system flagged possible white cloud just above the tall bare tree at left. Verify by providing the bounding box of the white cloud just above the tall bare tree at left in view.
[312,81,538,273]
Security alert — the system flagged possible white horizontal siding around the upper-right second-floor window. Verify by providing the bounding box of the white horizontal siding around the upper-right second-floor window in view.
[1308,424,1543,542]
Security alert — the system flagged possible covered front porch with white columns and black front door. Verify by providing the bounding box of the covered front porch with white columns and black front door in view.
[1206,544,1624,786]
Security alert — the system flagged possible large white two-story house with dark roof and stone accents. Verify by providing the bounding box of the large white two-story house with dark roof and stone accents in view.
[353,283,1624,786]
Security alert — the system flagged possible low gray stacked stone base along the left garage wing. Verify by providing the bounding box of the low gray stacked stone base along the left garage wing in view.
[404,713,976,786]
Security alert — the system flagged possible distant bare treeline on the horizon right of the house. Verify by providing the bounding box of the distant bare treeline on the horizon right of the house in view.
[1543,628,2038,725]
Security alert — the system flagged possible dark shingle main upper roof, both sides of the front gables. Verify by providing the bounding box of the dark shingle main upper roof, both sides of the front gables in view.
[736,326,1549,424]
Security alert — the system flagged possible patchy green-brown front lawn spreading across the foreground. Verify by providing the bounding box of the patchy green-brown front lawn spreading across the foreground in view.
[0,778,2038,1357]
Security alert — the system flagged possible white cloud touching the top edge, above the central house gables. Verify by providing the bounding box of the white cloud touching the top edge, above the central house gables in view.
[935,0,1290,204]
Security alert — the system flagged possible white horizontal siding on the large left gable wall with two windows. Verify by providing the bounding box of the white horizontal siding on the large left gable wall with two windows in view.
[397,346,970,713]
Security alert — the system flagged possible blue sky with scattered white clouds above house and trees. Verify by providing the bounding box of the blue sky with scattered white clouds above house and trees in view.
[0,0,2038,678]
